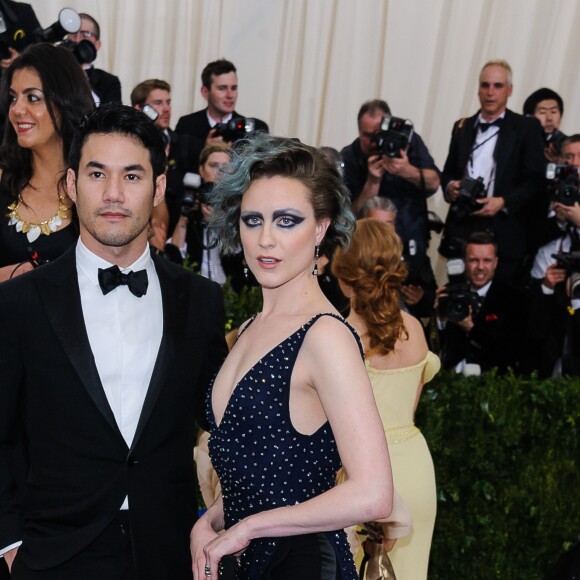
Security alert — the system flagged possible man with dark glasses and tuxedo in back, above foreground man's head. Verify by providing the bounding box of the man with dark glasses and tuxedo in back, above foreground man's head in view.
[67,12,122,107]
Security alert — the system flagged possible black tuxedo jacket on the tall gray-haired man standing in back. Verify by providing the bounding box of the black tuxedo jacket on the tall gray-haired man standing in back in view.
[441,110,545,260]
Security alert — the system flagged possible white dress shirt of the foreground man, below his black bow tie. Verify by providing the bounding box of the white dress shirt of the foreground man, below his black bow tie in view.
[76,240,163,509]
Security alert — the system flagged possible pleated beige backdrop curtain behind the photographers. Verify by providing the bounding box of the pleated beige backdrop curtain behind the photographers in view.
[30,0,580,272]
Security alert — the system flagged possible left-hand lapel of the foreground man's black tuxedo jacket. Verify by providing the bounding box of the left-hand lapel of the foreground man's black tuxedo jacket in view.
[38,247,121,435]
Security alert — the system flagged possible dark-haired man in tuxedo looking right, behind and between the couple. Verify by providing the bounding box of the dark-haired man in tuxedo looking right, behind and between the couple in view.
[175,58,268,173]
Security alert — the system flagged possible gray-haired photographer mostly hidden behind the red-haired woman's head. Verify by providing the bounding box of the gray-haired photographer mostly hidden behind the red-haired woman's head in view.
[360,197,437,318]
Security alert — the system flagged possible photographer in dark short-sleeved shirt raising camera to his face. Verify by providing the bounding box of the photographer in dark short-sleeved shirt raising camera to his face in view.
[341,99,439,260]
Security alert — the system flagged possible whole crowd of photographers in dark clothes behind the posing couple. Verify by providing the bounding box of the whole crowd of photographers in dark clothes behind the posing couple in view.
[0,1,580,376]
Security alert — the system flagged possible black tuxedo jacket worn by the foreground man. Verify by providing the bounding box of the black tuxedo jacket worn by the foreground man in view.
[0,248,227,580]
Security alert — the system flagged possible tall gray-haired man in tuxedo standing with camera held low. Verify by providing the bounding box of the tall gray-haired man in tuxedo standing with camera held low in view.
[439,60,545,283]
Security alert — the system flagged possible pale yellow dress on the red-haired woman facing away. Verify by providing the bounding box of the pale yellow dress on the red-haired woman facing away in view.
[357,352,441,580]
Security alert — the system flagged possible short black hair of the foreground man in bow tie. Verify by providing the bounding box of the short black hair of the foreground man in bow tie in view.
[68,103,167,185]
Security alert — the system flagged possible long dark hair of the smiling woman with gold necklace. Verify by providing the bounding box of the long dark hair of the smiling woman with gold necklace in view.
[0,43,95,199]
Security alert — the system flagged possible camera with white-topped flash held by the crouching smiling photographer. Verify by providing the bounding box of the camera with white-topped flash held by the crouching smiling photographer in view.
[437,258,479,322]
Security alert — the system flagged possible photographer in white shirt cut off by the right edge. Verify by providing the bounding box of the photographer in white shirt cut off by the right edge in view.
[526,135,580,377]
